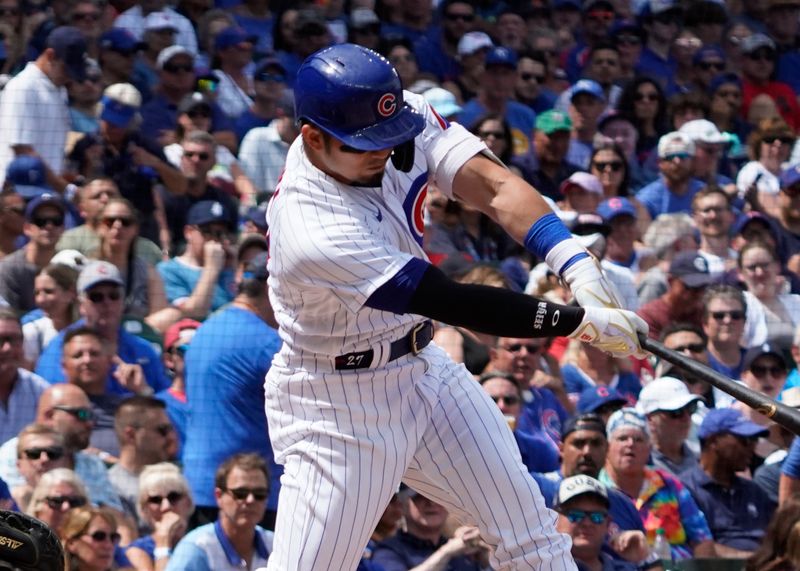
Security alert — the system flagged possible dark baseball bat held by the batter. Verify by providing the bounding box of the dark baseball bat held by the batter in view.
[639,334,800,434]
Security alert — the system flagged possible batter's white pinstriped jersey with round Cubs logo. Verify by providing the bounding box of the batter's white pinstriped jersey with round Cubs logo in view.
[267,93,486,359]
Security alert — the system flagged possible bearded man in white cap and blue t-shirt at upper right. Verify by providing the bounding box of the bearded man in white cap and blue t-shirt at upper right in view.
[636,131,703,218]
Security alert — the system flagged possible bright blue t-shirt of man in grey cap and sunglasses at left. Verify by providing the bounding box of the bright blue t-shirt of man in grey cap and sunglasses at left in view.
[36,319,172,396]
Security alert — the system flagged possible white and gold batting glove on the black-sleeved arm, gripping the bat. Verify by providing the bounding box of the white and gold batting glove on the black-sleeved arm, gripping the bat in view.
[569,307,650,359]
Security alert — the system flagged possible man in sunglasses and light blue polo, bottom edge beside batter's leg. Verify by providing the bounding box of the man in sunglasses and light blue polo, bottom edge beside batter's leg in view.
[166,454,273,571]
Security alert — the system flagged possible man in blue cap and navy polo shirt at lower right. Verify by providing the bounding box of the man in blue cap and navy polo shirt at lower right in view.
[681,408,775,559]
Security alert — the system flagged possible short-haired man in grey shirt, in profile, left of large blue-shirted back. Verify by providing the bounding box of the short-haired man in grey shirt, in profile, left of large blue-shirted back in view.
[108,396,178,533]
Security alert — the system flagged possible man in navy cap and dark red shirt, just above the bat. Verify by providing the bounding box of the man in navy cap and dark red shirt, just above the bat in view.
[636,250,711,339]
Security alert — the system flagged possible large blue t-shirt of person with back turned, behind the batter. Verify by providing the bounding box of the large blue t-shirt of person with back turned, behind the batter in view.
[182,307,283,510]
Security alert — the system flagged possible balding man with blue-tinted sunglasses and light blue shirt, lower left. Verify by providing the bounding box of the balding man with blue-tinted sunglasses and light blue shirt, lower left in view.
[0,383,122,515]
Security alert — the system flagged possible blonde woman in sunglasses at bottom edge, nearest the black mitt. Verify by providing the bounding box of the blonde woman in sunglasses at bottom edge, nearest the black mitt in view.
[58,507,130,571]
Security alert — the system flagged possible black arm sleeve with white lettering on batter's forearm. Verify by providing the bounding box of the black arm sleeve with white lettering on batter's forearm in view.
[407,265,584,338]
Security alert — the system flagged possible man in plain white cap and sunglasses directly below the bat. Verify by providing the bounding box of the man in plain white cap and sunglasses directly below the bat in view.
[637,377,702,476]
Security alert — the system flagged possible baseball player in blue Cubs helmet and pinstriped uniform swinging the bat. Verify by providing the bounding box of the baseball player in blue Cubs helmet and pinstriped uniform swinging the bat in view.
[266,44,647,571]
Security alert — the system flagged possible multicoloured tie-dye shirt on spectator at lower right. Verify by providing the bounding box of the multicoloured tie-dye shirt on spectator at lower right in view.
[599,468,714,561]
